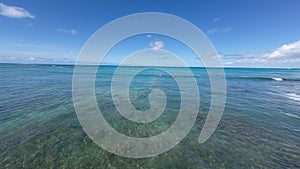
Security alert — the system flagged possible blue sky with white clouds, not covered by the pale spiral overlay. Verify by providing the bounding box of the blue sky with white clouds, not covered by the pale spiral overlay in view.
[0,0,300,68]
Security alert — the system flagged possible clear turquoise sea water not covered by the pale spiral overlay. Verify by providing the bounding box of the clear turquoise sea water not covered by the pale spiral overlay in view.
[0,64,300,168]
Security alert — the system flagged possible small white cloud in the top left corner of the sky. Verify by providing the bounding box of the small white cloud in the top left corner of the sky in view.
[0,3,35,19]
